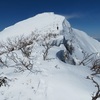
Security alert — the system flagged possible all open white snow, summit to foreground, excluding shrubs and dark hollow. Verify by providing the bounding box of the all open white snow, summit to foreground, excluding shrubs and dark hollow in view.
[0,12,100,100]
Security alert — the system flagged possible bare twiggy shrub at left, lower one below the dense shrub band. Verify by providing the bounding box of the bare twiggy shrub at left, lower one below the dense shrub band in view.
[6,52,33,72]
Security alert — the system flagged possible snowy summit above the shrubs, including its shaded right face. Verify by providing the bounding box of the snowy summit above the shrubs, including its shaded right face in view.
[0,13,100,64]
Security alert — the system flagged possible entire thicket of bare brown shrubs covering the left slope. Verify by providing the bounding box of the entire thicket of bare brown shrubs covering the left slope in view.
[0,33,38,71]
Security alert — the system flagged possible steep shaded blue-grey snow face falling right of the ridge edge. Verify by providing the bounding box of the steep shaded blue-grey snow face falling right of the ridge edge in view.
[62,27,100,64]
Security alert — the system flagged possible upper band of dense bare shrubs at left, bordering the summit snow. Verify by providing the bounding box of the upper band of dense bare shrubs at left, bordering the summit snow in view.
[0,33,38,55]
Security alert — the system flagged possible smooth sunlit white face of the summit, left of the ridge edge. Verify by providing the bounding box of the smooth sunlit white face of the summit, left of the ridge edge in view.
[0,13,70,40]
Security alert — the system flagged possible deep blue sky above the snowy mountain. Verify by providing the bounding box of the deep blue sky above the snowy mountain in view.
[0,0,100,38]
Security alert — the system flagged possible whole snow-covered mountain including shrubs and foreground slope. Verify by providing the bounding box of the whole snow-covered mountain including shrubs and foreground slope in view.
[0,13,100,100]
